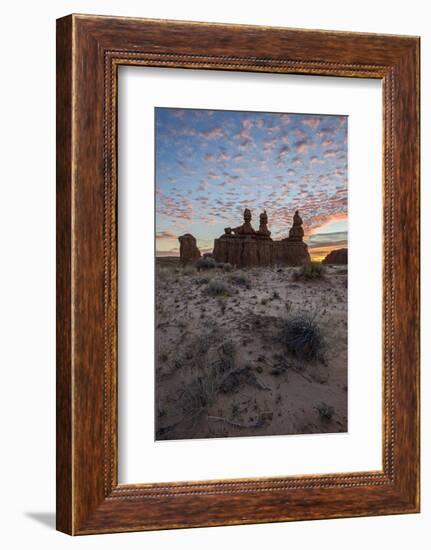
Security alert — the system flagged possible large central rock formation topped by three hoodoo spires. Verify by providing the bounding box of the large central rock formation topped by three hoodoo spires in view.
[213,208,310,267]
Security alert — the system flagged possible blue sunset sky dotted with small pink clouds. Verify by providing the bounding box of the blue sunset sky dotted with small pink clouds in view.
[155,107,347,260]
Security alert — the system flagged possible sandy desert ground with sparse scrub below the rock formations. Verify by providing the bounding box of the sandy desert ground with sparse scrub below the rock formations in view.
[155,258,347,440]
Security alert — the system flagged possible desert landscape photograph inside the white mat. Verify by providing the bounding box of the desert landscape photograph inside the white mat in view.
[154,107,348,441]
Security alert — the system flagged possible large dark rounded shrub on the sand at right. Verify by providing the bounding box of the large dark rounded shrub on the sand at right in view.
[281,313,325,360]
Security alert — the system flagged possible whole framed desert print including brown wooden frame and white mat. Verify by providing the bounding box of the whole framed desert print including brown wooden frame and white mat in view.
[57,15,419,534]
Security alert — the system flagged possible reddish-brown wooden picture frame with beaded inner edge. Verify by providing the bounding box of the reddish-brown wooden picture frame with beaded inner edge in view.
[57,15,419,534]
